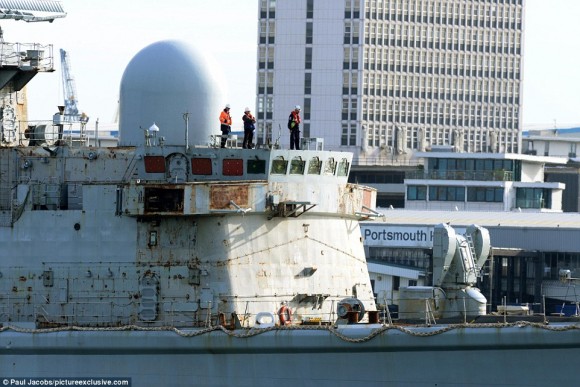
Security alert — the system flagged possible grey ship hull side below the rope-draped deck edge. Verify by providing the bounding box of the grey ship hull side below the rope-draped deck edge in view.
[0,323,580,386]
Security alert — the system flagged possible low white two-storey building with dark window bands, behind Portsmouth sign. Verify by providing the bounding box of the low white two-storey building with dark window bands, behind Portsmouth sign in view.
[405,151,568,212]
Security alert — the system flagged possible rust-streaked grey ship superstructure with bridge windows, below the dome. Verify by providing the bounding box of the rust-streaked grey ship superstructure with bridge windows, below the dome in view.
[0,141,375,326]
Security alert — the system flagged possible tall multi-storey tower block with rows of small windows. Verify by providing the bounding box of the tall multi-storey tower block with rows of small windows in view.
[256,0,525,163]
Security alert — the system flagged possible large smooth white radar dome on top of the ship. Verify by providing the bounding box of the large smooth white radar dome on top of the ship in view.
[119,40,224,146]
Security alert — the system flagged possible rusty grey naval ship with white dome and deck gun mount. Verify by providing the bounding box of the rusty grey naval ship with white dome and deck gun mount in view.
[0,0,580,386]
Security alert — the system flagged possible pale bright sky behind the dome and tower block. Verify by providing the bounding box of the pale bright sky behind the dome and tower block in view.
[0,0,580,129]
